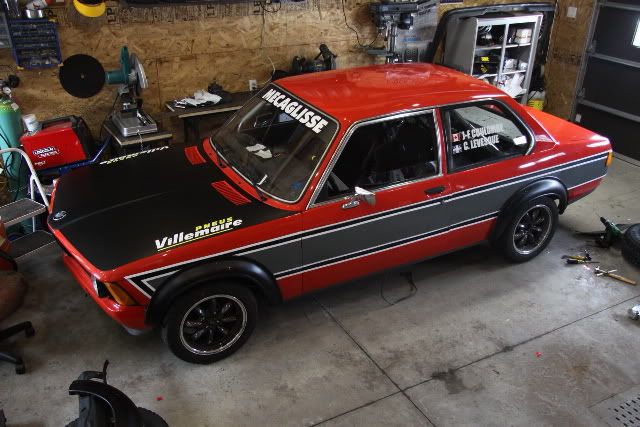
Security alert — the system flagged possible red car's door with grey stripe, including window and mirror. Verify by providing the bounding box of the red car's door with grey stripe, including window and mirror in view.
[301,110,449,292]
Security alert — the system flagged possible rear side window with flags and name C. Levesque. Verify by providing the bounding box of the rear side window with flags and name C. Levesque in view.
[442,103,531,172]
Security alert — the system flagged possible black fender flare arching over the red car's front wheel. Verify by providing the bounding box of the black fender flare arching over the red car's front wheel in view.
[145,257,282,325]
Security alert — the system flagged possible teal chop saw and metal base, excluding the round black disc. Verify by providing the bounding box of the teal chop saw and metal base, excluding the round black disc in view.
[106,46,158,136]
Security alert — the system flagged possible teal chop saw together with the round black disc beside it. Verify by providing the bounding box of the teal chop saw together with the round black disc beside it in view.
[60,46,158,137]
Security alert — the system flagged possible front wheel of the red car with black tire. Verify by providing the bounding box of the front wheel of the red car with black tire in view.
[162,283,258,364]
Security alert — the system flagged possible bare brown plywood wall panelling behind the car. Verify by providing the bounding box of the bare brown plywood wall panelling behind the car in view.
[0,0,593,142]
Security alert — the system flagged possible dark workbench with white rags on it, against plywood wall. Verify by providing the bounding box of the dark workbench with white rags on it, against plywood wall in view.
[164,92,256,144]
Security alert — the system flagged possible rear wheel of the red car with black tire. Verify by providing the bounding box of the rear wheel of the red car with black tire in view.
[497,197,558,262]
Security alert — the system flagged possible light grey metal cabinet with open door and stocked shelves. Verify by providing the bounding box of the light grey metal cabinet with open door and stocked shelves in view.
[444,14,542,104]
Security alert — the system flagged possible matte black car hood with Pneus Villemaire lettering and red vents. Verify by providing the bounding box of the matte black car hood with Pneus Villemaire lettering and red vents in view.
[48,145,292,270]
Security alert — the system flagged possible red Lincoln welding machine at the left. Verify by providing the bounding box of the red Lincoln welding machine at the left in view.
[20,116,96,172]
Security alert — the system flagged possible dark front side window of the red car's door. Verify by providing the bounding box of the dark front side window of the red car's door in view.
[317,112,438,202]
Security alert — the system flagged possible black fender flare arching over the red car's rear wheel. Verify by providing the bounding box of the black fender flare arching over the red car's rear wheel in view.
[490,177,568,241]
